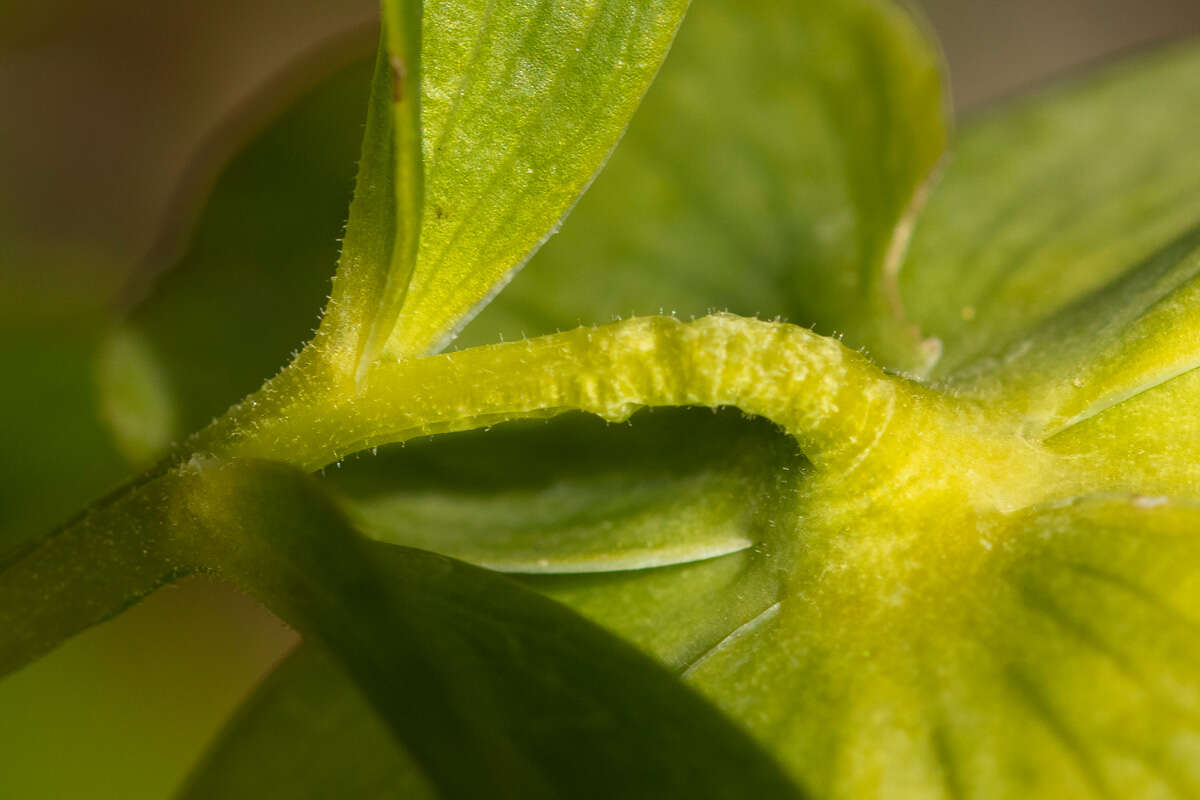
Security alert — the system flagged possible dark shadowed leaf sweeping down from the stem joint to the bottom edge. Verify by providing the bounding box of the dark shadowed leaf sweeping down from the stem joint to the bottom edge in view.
[187,463,797,798]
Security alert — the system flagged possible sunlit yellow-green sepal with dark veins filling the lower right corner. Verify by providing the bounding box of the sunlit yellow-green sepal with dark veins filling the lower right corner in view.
[672,497,1200,798]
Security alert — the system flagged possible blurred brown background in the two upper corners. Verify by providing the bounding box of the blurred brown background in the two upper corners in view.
[0,0,1200,309]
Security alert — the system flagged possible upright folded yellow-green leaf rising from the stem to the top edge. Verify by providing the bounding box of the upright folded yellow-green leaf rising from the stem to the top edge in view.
[329,0,686,362]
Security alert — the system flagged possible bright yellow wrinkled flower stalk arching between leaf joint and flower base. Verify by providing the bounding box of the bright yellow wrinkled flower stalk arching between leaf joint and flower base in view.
[187,314,922,470]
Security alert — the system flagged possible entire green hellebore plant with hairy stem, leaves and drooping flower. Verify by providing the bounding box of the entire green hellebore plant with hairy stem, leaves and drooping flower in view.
[0,0,1200,798]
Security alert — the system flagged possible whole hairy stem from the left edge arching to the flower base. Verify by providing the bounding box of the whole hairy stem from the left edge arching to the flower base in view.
[0,314,912,674]
